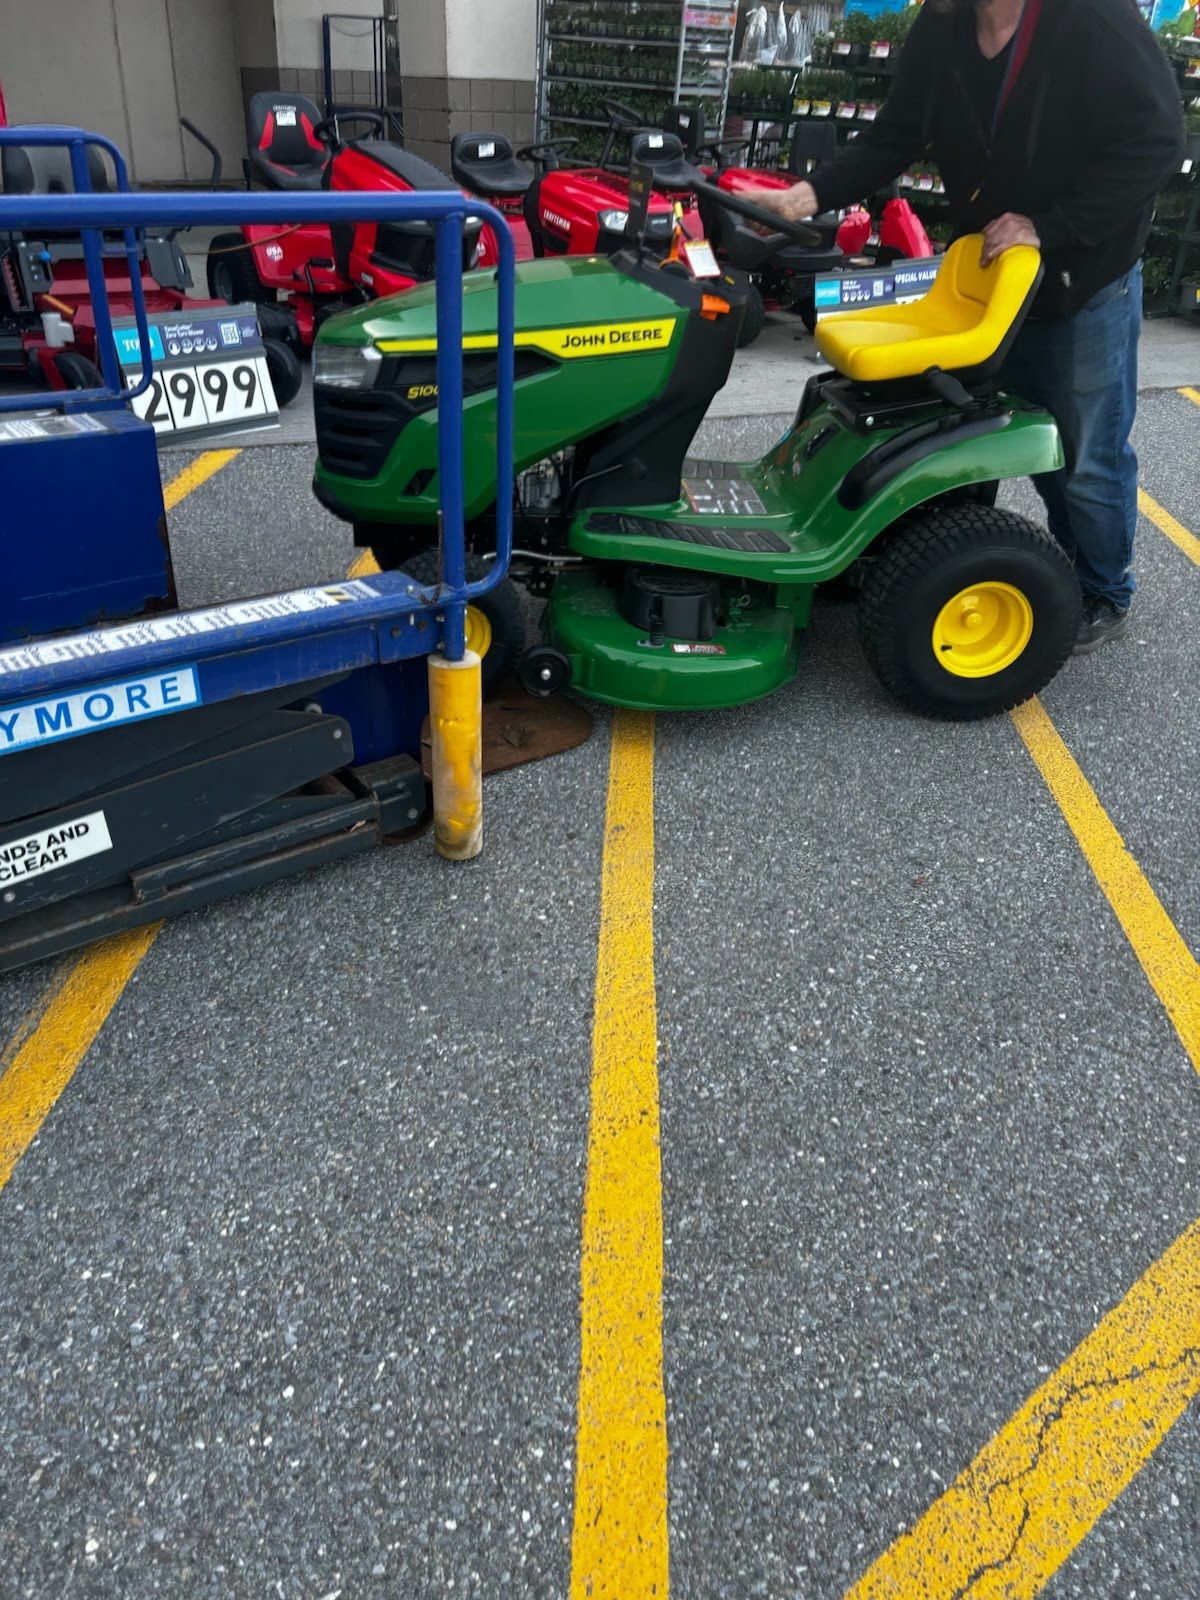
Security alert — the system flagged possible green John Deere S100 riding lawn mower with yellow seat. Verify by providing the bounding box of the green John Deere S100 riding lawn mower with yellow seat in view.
[314,168,1080,718]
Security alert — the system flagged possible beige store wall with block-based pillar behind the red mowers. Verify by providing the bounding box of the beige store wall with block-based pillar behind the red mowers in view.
[0,0,538,184]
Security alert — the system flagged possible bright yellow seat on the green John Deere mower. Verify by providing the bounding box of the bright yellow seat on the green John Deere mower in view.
[816,234,1042,384]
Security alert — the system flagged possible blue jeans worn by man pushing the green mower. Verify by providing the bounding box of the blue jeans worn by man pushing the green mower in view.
[1000,262,1142,611]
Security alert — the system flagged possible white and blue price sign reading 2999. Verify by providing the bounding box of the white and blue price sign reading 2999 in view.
[114,306,278,434]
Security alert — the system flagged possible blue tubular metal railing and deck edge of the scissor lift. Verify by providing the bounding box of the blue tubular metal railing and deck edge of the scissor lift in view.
[0,126,515,675]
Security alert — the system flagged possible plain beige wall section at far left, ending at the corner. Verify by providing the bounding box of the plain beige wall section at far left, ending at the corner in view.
[0,0,245,184]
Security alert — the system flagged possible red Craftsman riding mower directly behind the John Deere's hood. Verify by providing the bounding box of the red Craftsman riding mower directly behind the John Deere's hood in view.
[450,101,690,259]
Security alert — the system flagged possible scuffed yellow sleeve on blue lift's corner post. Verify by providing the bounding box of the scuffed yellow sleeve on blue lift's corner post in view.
[429,650,483,861]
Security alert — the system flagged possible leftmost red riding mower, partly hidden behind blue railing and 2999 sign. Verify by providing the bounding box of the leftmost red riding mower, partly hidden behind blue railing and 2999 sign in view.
[0,144,301,406]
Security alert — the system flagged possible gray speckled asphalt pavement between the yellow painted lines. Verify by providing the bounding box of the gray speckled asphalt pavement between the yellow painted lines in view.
[0,371,1200,1600]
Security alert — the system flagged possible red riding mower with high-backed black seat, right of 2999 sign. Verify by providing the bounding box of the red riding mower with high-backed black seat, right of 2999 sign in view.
[182,90,498,350]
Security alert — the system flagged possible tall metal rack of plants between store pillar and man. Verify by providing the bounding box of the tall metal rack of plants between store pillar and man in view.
[538,0,738,154]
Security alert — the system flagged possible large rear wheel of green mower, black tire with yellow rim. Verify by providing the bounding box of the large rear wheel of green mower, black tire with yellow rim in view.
[859,504,1080,722]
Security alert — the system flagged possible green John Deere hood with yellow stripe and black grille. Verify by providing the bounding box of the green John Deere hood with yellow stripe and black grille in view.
[314,256,713,523]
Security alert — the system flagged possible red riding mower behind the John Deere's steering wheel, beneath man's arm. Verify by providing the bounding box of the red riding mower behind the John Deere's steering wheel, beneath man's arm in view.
[666,106,934,346]
